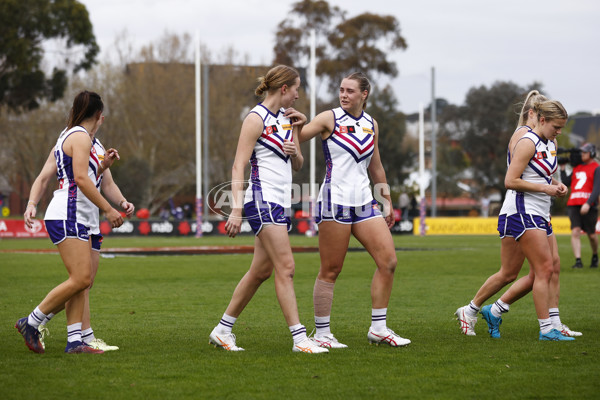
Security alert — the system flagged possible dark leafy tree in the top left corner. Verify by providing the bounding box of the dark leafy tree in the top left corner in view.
[0,0,99,109]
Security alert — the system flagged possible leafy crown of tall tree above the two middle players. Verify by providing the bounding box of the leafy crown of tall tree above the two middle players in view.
[274,0,407,92]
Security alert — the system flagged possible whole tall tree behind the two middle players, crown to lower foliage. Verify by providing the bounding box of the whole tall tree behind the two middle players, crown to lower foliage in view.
[274,0,411,197]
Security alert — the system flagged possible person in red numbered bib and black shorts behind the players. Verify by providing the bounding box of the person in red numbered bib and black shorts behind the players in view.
[560,143,600,268]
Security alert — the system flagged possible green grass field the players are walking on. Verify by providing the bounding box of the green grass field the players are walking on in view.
[0,236,600,400]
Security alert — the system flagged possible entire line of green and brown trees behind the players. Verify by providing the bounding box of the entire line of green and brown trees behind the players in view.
[0,0,584,219]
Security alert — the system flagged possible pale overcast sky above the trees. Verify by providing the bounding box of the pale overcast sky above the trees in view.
[80,0,600,114]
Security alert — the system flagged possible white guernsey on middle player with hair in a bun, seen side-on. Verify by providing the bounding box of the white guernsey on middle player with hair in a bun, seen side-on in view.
[244,104,292,208]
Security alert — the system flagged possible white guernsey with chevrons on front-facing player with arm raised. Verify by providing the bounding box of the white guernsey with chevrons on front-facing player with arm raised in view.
[317,107,375,207]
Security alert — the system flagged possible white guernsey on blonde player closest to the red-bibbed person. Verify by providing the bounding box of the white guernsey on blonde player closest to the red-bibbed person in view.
[500,130,558,221]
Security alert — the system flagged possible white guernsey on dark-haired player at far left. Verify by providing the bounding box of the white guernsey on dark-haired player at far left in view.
[44,126,100,228]
